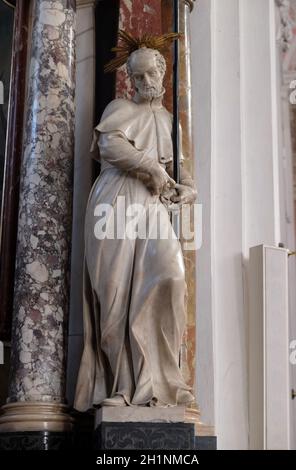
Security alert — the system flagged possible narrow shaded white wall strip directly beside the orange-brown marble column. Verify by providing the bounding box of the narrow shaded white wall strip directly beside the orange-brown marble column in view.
[191,0,215,426]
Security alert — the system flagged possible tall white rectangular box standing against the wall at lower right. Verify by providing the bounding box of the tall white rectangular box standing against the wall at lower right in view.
[249,245,290,450]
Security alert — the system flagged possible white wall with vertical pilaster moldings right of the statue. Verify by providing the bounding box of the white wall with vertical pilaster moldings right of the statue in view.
[192,0,280,449]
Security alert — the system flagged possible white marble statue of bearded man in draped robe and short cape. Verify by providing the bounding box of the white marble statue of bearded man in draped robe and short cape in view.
[74,48,196,411]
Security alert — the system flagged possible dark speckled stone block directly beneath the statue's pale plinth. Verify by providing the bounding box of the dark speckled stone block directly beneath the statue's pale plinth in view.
[95,422,195,450]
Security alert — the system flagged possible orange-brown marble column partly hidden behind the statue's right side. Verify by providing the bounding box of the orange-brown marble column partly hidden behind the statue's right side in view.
[176,0,216,440]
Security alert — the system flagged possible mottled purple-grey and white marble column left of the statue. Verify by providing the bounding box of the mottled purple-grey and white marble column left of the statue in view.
[0,0,76,440]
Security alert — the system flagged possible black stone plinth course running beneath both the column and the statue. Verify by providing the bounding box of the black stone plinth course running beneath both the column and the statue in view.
[0,422,217,451]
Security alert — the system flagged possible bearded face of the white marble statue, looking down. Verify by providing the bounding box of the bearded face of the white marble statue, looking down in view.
[131,50,164,100]
